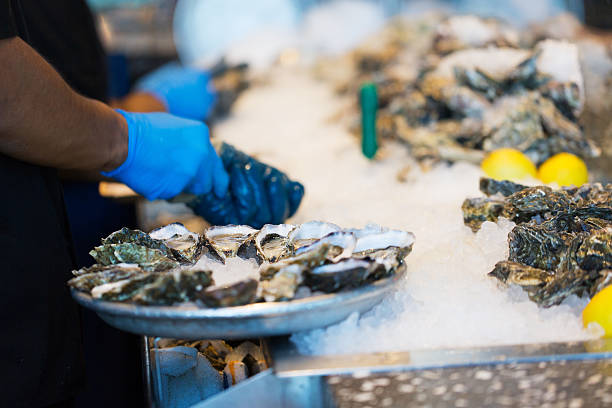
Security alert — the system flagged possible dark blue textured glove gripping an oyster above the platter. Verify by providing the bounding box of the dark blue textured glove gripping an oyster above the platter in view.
[188,144,304,228]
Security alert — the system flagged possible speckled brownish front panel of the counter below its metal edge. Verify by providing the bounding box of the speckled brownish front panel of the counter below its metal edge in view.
[326,358,612,408]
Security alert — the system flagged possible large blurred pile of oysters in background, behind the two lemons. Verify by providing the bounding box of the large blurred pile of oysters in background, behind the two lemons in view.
[340,16,600,166]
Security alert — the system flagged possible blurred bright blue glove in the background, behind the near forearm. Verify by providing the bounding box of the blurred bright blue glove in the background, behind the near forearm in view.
[136,62,216,120]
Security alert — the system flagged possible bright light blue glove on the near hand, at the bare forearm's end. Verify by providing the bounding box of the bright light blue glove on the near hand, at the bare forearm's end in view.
[102,110,229,200]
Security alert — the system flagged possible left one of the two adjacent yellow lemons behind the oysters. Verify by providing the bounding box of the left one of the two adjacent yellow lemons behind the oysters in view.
[480,148,536,181]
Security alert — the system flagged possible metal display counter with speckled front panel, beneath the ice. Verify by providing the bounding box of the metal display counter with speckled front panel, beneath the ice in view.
[144,337,612,408]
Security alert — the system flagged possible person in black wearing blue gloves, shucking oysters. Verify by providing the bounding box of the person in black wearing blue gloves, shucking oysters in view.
[0,0,303,407]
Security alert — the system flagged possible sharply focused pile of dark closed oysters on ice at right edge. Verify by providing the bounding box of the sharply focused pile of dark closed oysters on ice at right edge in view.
[462,178,612,307]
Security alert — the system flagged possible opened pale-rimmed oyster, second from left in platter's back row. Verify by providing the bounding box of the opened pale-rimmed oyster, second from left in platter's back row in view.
[204,225,257,259]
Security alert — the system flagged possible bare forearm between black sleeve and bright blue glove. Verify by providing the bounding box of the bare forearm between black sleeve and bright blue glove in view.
[0,37,128,171]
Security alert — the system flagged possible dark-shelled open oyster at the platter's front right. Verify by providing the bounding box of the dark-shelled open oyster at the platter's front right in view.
[304,259,373,293]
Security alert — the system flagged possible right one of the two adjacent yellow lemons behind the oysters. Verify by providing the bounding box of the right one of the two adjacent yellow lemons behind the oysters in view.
[538,153,589,187]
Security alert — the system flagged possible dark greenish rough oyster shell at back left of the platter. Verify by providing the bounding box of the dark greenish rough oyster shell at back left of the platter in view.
[89,243,180,272]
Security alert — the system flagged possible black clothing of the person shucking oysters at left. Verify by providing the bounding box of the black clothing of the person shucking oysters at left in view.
[0,0,107,407]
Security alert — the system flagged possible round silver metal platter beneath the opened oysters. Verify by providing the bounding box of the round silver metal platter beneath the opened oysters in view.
[72,268,405,340]
